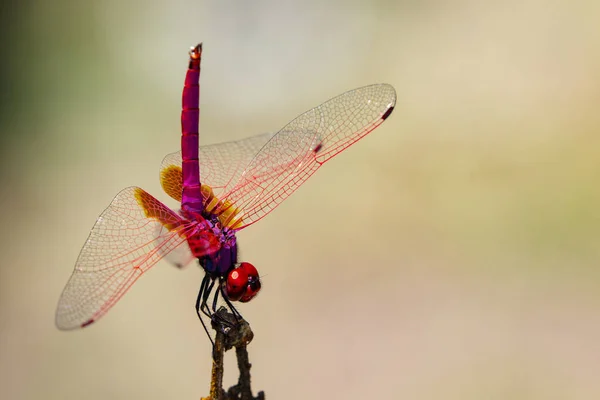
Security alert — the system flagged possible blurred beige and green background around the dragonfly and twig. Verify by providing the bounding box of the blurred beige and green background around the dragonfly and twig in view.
[0,0,600,400]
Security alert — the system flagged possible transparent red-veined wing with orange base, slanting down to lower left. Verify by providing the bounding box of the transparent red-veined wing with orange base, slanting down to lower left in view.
[56,187,214,329]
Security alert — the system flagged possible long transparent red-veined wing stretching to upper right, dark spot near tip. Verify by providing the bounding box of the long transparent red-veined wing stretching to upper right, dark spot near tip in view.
[222,84,396,229]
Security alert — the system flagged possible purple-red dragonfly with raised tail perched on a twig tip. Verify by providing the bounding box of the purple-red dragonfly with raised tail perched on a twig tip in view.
[56,44,396,337]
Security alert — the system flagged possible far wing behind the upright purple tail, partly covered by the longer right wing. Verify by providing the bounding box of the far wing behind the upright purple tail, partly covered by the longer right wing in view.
[160,133,273,201]
